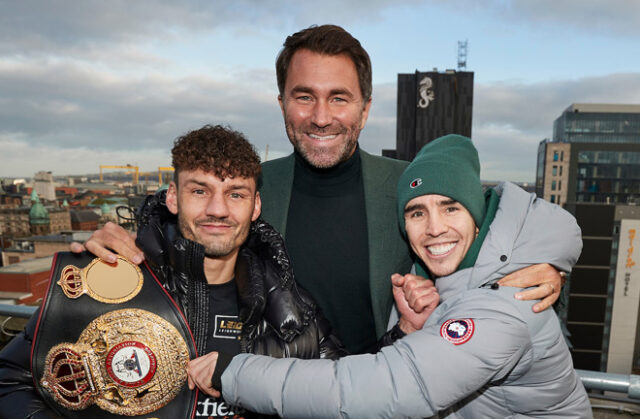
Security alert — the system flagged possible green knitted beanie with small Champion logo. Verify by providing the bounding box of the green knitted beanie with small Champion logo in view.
[397,134,485,234]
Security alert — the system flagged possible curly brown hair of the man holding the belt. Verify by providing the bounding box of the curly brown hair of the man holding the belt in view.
[171,125,261,184]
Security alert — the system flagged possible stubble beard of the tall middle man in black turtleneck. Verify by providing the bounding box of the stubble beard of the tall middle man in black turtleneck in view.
[285,118,362,169]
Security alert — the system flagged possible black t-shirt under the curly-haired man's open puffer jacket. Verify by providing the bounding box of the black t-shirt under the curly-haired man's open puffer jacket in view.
[195,281,245,419]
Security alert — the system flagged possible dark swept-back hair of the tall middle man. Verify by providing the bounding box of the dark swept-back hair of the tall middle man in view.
[276,25,371,103]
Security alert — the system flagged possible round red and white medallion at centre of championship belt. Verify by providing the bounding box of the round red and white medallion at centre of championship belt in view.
[105,341,157,388]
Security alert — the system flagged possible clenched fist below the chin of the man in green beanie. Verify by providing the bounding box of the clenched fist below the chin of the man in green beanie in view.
[391,274,440,334]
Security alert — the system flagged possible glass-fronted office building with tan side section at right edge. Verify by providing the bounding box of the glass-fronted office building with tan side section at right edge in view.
[536,104,640,204]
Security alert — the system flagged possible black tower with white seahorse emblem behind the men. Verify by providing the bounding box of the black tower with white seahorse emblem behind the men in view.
[382,70,473,161]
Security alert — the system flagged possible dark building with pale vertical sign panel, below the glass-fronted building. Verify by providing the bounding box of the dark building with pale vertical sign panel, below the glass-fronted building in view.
[565,203,640,374]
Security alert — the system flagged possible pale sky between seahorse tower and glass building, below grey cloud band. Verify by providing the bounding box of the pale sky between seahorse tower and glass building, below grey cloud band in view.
[472,73,640,182]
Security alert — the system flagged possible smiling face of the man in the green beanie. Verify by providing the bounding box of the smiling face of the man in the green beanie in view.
[404,194,478,277]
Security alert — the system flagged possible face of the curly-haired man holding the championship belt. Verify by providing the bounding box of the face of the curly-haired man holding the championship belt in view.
[167,169,261,258]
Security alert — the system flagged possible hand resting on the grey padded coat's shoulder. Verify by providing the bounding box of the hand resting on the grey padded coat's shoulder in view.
[498,263,564,313]
